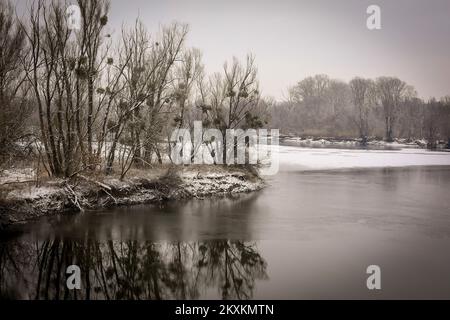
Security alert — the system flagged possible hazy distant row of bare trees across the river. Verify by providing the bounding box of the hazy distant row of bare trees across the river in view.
[271,75,450,148]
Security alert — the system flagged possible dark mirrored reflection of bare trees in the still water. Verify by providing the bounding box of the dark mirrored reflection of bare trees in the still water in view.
[0,239,267,300]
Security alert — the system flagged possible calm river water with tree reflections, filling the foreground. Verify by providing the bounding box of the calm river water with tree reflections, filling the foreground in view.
[0,146,450,299]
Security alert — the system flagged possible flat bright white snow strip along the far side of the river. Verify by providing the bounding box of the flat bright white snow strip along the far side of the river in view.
[279,146,450,170]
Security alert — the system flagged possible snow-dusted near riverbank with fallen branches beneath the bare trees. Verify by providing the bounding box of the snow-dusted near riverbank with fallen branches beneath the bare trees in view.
[0,166,265,230]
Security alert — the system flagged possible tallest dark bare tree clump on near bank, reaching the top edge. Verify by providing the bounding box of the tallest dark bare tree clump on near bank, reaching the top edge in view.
[22,0,112,176]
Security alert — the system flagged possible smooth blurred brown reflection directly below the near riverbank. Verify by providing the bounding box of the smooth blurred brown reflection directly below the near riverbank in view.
[14,192,260,242]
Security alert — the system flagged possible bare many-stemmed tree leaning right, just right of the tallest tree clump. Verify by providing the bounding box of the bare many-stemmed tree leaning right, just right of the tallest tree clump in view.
[106,21,187,176]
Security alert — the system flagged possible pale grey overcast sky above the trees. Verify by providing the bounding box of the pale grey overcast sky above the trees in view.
[19,0,450,99]
